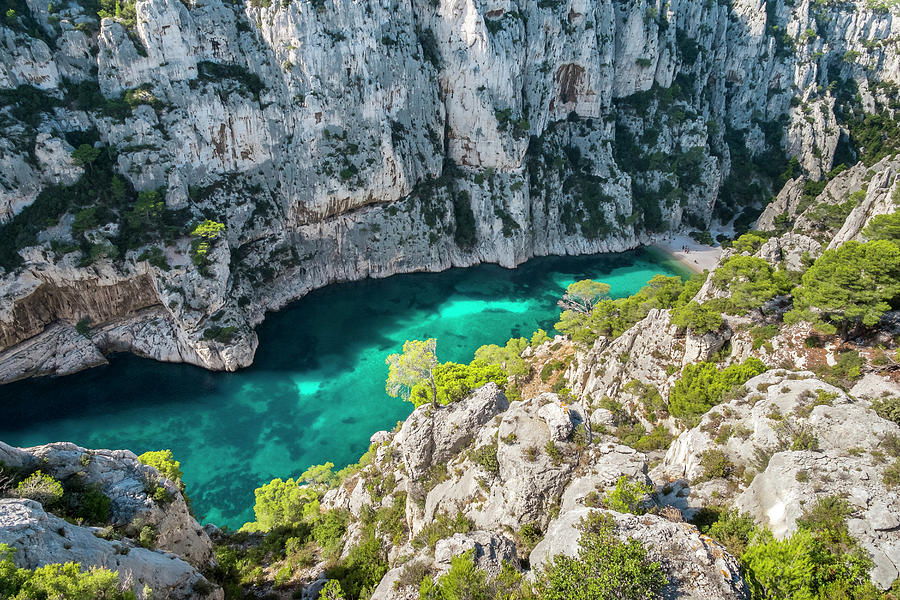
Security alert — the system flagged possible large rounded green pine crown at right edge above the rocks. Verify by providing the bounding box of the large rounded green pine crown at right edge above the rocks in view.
[785,240,900,337]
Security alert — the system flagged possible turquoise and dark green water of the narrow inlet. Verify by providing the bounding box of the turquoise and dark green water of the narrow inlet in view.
[0,251,683,527]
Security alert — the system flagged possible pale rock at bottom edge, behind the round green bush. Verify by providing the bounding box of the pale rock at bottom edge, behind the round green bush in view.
[529,508,750,600]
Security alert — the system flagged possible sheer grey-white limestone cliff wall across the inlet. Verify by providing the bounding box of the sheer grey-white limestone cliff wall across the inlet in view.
[0,0,900,381]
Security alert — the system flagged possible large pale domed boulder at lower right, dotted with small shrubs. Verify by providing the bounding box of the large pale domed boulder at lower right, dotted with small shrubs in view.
[651,370,900,588]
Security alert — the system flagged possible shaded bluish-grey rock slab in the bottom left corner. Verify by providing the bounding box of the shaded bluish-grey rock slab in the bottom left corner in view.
[0,498,224,600]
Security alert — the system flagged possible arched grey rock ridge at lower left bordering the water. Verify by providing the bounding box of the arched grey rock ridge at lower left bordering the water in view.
[0,442,213,567]
